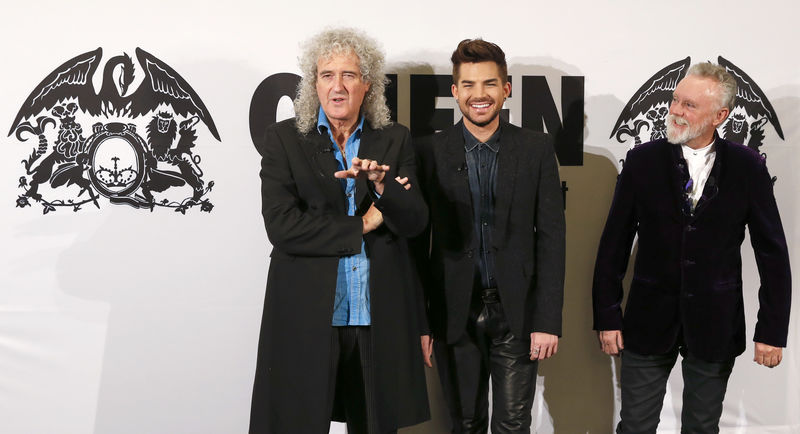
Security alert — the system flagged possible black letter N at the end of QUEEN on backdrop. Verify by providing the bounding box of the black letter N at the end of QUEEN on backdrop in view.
[522,75,583,166]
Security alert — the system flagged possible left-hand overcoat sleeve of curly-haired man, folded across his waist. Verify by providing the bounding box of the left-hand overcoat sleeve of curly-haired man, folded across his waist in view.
[259,126,363,256]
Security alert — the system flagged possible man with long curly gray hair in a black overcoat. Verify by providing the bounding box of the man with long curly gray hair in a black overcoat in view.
[250,29,429,434]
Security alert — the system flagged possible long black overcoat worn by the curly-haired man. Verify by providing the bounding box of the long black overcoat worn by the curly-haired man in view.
[250,120,429,434]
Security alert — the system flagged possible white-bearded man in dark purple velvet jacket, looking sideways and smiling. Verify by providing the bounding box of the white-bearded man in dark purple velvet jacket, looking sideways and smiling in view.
[592,63,791,434]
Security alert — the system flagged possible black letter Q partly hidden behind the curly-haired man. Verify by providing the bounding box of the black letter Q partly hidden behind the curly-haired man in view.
[250,72,300,148]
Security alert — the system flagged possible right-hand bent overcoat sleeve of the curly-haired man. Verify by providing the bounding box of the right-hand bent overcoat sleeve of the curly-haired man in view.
[374,128,428,238]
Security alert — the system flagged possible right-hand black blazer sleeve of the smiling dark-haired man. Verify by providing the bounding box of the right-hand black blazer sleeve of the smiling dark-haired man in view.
[532,136,566,336]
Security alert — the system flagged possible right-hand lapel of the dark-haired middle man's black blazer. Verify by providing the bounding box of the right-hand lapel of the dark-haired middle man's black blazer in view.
[492,122,521,248]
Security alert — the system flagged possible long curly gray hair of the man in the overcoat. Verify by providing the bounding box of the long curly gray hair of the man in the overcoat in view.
[294,28,392,134]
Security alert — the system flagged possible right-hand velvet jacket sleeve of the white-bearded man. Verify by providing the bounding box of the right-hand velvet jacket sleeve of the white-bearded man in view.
[747,161,792,347]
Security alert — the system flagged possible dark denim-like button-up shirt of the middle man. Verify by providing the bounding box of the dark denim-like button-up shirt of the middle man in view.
[464,127,500,288]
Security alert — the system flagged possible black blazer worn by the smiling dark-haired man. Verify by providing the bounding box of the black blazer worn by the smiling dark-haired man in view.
[414,121,565,343]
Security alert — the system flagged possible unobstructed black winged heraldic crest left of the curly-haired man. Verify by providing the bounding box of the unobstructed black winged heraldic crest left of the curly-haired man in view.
[8,48,220,214]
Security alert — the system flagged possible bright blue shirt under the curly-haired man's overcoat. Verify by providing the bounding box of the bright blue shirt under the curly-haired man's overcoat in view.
[317,107,371,326]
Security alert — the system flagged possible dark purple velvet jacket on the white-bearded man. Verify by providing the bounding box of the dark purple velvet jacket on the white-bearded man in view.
[592,138,791,361]
